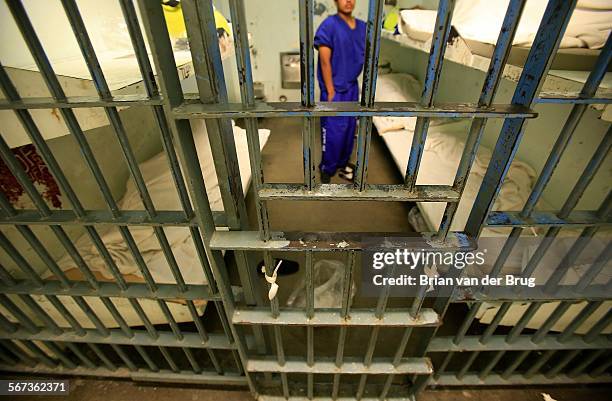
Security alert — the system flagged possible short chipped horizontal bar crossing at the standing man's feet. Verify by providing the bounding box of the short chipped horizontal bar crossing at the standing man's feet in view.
[259,184,459,202]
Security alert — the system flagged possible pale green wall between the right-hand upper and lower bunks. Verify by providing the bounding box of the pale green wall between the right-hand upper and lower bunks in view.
[380,40,612,210]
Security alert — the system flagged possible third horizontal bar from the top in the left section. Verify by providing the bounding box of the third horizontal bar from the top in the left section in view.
[0,280,221,301]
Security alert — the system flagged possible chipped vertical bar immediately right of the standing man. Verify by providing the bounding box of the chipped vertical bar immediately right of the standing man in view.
[354,0,384,191]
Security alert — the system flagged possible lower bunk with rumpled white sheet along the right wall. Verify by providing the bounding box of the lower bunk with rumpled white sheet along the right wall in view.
[373,73,612,333]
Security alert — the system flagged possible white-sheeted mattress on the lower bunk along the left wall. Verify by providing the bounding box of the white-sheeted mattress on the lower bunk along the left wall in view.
[27,120,270,328]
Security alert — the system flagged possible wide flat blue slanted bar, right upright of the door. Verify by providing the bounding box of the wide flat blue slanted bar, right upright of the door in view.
[465,0,576,237]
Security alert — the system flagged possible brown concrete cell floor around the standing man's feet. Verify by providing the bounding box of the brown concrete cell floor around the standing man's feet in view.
[247,118,413,232]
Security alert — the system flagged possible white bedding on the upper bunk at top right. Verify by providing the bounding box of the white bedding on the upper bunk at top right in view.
[400,0,612,49]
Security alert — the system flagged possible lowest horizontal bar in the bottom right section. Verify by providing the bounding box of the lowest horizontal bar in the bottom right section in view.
[429,373,612,387]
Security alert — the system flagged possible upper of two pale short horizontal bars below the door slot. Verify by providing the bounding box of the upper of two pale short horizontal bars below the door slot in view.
[232,308,440,327]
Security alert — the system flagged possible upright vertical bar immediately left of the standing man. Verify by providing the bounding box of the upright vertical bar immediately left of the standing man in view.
[299,0,316,191]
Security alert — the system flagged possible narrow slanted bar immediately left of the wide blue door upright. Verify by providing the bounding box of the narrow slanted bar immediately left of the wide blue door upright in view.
[437,0,526,239]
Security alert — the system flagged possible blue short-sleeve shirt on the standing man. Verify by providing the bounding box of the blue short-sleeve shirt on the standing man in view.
[314,14,366,93]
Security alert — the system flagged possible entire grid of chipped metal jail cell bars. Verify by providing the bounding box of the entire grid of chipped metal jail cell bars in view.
[0,0,612,400]
